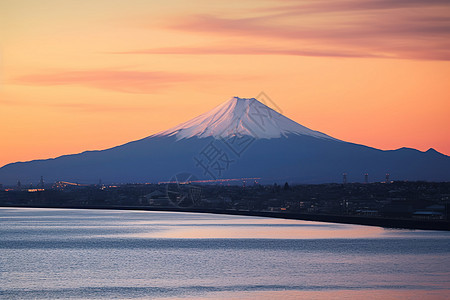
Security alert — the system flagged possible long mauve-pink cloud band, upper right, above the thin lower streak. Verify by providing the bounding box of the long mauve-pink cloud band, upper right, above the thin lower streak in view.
[168,14,450,42]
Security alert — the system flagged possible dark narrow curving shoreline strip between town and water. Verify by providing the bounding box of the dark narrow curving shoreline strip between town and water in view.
[0,204,450,231]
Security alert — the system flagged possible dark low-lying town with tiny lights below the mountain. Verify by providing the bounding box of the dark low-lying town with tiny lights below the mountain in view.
[0,178,450,230]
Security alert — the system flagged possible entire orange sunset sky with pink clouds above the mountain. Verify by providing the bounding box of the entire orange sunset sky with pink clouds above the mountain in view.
[0,0,450,166]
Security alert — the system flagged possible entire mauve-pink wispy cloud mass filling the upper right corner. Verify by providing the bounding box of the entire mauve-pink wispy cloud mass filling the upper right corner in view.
[120,0,450,60]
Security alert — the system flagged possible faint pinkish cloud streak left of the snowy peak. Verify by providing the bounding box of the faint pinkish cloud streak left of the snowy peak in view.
[11,70,206,94]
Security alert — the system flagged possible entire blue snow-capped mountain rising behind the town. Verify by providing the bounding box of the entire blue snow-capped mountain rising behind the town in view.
[0,97,450,185]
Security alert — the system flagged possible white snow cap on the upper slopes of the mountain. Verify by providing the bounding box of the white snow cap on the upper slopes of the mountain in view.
[153,97,338,141]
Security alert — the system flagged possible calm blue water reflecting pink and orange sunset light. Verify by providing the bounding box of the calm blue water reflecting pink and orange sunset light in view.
[0,208,450,299]
